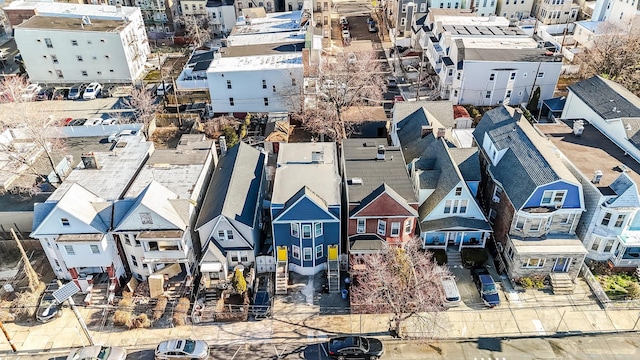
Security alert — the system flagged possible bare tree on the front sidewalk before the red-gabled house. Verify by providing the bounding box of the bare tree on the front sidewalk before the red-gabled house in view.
[351,239,449,338]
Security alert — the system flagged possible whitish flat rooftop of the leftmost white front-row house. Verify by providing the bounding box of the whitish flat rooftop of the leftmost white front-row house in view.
[49,136,154,200]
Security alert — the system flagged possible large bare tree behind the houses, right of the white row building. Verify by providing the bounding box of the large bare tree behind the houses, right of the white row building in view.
[292,52,385,142]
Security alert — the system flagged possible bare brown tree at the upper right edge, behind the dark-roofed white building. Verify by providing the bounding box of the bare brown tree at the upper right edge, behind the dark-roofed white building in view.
[577,22,640,96]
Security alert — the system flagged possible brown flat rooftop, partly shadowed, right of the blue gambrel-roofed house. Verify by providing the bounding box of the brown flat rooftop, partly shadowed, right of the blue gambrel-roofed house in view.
[536,120,640,194]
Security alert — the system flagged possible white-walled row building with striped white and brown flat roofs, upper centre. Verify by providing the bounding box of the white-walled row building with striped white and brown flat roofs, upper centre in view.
[206,11,308,113]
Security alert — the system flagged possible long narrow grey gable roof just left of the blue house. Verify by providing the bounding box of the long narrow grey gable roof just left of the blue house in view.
[196,142,264,229]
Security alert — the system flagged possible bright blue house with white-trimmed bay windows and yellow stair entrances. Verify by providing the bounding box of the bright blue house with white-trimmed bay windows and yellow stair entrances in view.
[269,142,341,292]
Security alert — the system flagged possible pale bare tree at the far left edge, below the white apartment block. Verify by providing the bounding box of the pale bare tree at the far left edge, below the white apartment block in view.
[0,76,64,195]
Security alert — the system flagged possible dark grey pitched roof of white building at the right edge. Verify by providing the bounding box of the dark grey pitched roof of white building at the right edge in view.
[569,76,640,120]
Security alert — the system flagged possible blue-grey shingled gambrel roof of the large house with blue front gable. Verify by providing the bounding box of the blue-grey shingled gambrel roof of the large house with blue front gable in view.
[473,106,578,209]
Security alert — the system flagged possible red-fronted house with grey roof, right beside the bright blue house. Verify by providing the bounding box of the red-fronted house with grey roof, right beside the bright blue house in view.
[341,138,418,256]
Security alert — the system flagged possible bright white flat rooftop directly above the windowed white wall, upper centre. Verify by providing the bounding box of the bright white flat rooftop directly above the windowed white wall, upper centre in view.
[207,52,302,73]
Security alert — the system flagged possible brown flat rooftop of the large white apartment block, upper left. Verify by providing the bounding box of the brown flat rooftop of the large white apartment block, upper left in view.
[16,15,129,32]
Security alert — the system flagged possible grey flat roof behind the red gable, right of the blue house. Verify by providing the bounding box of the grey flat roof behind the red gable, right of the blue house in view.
[342,138,418,203]
